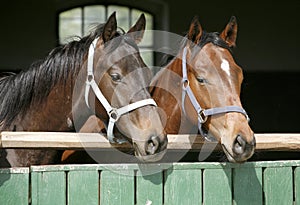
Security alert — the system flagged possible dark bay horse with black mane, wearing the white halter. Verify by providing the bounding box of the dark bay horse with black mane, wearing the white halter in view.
[0,13,167,167]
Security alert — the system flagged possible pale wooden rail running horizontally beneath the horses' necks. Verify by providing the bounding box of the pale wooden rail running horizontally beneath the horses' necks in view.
[0,132,300,151]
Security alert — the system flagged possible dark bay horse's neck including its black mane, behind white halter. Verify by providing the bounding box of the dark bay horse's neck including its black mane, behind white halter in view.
[0,42,87,131]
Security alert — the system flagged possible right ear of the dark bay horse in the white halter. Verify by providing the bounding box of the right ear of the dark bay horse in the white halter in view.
[127,14,146,44]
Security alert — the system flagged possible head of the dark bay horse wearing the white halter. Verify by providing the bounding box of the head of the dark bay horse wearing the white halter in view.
[79,13,167,161]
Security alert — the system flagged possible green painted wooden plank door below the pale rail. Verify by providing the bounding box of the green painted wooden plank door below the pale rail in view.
[0,161,300,205]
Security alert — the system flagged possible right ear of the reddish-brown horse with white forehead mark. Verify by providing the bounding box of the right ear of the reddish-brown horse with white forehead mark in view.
[220,16,237,47]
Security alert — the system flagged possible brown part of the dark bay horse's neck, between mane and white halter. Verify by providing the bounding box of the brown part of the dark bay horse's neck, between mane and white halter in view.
[19,51,88,131]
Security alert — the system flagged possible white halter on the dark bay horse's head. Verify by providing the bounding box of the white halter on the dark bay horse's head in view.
[85,38,157,144]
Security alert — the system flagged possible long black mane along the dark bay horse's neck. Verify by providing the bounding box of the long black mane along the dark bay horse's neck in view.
[0,25,129,128]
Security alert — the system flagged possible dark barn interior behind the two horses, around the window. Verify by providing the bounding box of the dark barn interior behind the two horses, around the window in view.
[0,0,300,133]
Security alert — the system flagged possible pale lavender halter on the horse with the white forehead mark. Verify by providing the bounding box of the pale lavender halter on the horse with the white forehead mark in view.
[181,47,250,141]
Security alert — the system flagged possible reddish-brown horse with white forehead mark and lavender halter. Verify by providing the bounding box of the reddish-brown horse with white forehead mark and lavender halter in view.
[151,17,255,162]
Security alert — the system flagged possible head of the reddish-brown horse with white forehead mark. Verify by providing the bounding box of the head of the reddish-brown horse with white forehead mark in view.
[183,17,255,162]
